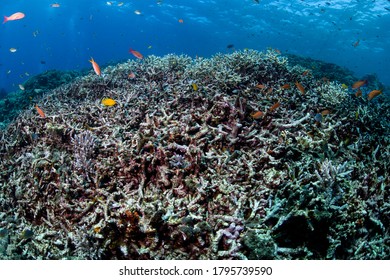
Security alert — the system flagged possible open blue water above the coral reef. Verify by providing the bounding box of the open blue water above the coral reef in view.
[0,0,390,91]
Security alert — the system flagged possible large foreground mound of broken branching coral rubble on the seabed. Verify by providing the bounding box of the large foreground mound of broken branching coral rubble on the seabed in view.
[0,50,390,259]
